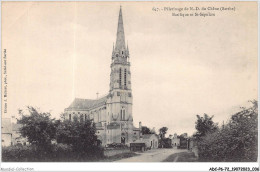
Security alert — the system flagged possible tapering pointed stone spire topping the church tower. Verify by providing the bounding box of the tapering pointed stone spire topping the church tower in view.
[115,6,125,51]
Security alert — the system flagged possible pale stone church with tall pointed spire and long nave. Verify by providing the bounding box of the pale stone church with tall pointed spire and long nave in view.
[65,7,141,146]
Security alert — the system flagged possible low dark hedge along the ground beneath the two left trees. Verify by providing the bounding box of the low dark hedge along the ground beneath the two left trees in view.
[2,144,104,162]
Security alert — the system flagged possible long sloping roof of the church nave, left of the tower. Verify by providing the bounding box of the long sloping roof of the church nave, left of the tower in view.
[66,96,107,110]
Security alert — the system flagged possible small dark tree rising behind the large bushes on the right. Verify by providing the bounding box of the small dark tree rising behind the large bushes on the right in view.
[194,114,218,140]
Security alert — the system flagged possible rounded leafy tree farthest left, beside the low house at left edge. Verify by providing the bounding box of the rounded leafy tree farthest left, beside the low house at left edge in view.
[18,106,57,149]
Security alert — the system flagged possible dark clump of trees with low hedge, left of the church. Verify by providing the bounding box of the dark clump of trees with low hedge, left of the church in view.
[2,107,104,162]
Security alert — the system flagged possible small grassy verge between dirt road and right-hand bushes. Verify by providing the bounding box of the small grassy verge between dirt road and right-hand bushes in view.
[163,152,198,162]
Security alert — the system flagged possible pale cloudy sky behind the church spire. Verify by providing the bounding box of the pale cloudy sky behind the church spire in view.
[2,2,258,135]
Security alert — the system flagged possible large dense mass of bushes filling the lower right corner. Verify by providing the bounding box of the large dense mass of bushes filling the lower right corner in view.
[197,101,258,162]
